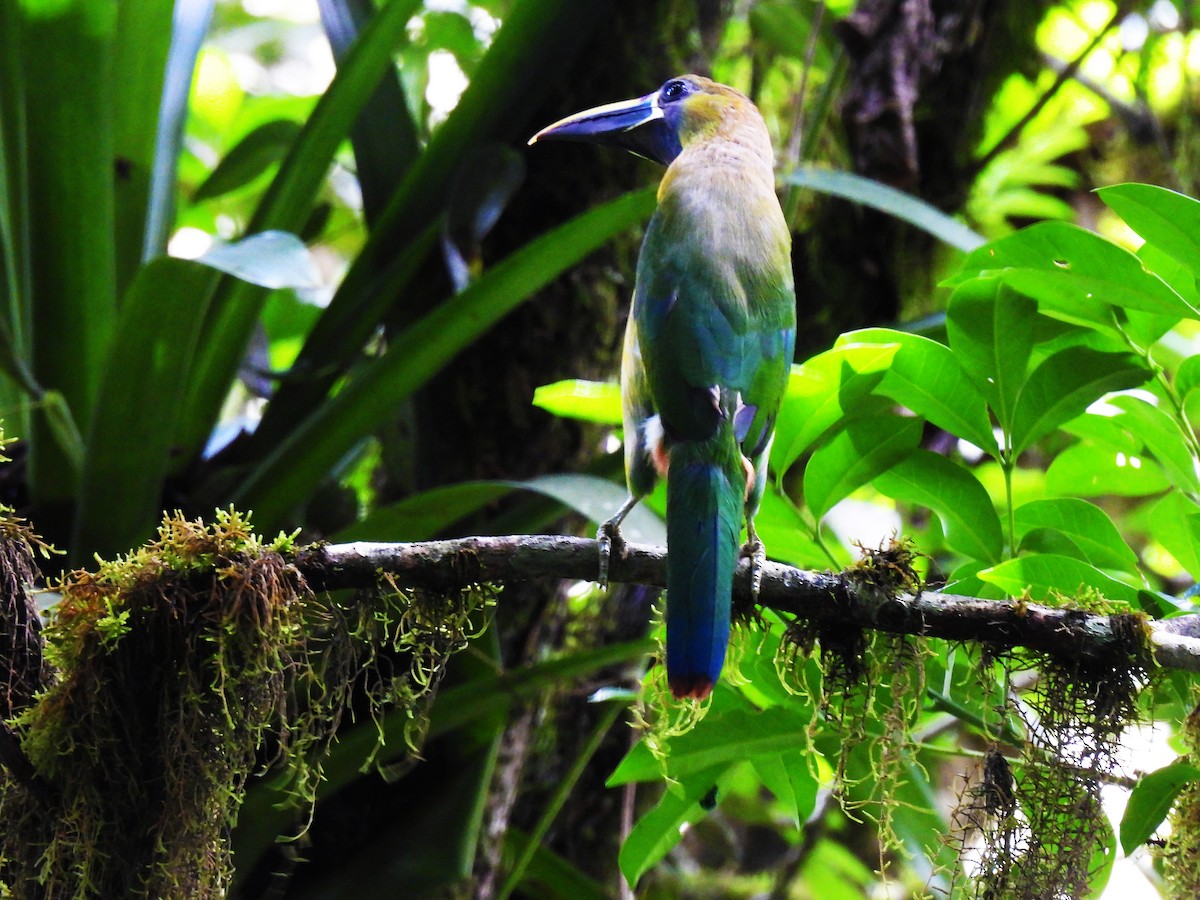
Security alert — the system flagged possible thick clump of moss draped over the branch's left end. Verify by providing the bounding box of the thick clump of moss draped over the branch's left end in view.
[0,511,490,899]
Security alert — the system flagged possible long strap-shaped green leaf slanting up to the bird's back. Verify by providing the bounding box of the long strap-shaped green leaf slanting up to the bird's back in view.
[233,191,654,532]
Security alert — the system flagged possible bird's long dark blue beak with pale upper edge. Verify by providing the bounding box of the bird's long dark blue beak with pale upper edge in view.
[529,91,680,166]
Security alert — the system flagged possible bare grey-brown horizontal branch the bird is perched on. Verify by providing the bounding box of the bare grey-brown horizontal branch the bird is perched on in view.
[295,535,1200,672]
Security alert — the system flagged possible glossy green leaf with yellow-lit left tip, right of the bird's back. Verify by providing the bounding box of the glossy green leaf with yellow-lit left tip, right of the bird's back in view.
[834,328,998,456]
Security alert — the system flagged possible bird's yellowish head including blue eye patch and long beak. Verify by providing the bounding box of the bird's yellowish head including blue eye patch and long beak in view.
[529,74,766,166]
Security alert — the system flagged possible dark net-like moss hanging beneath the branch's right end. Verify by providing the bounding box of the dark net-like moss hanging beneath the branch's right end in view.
[954,614,1150,900]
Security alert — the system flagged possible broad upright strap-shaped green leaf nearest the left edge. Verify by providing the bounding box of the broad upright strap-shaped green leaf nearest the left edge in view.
[18,0,118,503]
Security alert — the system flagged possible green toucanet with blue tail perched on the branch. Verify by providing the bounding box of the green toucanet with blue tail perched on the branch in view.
[529,74,796,700]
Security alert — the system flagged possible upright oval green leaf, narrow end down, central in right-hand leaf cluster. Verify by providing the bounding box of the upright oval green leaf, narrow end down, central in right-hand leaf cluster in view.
[946,278,1039,433]
